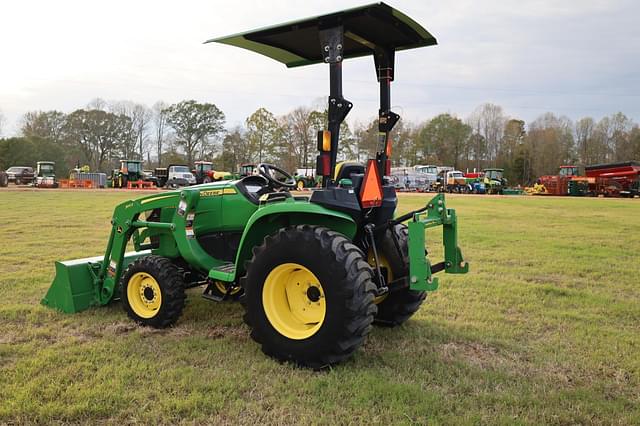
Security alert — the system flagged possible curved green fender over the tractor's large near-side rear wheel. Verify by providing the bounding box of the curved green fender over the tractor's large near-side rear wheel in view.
[235,199,357,278]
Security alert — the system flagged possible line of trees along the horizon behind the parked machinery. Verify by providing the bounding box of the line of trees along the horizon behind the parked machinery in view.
[0,99,640,184]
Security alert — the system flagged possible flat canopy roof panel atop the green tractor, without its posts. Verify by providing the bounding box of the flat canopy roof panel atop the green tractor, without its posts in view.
[205,3,437,67]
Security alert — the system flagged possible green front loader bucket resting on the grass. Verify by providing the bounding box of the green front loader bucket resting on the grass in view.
[41,250,150,314]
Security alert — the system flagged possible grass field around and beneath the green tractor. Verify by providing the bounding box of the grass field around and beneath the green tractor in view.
[0,191,640,424]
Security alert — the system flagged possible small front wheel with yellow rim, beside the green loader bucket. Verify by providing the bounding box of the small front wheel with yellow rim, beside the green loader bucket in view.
[120,256,186,328]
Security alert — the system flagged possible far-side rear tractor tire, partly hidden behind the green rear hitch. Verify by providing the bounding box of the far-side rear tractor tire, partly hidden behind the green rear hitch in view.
[375,224,427,327]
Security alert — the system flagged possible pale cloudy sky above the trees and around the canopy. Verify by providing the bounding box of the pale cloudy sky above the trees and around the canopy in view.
[0,0,640,136]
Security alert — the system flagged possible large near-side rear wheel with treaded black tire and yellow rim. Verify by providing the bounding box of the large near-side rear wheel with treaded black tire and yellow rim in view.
[241,225,376,369]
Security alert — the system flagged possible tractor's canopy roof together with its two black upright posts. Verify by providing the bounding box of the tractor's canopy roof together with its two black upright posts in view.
[205,3,437,188]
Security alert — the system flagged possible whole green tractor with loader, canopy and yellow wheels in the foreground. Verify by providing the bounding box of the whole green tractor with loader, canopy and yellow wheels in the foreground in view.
[42,4,469,368]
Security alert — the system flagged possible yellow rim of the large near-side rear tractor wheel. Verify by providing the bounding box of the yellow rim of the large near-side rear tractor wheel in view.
[262,263,327,340]
